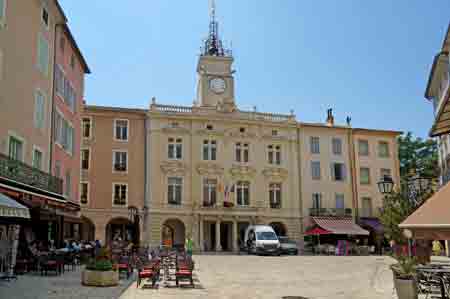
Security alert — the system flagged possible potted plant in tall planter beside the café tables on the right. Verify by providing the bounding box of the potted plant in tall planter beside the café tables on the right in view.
[391,256,417,299]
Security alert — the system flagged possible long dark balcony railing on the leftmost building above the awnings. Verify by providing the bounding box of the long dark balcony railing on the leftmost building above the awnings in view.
[0,153,63,195]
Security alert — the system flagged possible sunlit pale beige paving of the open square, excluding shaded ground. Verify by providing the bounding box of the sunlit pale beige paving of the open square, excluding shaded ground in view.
[121,255,396,299]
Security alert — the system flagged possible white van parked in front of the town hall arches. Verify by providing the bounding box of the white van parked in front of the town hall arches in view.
[245,225,281,255]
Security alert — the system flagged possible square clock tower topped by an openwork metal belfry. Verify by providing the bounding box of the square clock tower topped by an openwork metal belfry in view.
[197,0,236,111]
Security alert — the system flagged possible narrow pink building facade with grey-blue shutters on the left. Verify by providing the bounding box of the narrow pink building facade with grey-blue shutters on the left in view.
[50,24,90,239]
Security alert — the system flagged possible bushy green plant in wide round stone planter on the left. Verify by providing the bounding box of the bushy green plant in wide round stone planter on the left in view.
[81,247,119,287]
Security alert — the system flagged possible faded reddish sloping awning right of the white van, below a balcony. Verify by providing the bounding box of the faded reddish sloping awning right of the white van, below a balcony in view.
[313,217,369,236]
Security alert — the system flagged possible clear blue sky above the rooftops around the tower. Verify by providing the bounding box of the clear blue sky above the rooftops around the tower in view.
[60,0,450,136]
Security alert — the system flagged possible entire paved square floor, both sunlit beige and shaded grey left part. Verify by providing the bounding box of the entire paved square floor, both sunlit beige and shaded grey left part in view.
[0,255,395,299]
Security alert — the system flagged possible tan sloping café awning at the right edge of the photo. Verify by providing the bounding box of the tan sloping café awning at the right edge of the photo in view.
[399,183,450,236]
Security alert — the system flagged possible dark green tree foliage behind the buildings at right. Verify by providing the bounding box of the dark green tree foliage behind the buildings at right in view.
[398,132,439,180]
